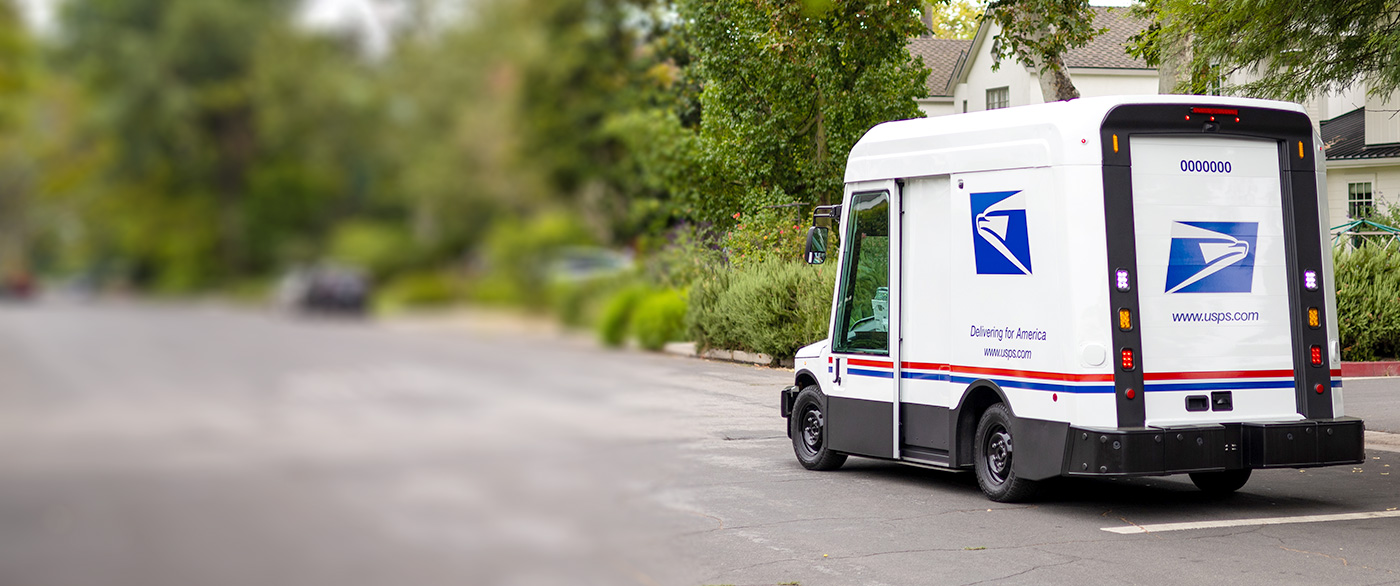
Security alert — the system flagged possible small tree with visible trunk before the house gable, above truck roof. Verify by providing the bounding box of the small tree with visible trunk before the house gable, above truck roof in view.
[987,0,1106,102]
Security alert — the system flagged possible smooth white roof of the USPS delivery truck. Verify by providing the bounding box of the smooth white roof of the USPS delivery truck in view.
[846,95,1306,183]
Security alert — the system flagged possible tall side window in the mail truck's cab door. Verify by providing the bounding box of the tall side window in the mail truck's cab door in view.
[833,192,889,355]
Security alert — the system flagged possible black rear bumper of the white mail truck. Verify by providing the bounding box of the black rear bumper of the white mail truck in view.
[1063,417,1365,476]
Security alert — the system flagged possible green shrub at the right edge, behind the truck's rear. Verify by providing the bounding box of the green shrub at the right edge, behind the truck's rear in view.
[1333,243,1400,361]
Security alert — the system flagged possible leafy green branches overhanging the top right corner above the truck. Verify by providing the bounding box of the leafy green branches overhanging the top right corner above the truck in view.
[1134,0,1400,101]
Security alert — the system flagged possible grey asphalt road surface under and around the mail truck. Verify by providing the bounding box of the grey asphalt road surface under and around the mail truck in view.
[0,303,1400,586]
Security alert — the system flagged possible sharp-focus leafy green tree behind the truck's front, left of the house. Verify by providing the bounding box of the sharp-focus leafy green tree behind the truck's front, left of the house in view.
[678,0,928,221]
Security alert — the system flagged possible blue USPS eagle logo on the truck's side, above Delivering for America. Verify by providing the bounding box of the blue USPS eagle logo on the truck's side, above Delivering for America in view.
[970,192,1030,274]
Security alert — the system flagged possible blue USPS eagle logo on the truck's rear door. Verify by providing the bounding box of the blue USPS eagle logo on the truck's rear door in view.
[1166,222,1259,294]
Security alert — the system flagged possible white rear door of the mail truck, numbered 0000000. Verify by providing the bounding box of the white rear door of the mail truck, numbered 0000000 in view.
[1117,134,1299,425]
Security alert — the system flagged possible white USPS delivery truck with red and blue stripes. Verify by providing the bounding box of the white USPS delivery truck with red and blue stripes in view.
[781,95,1364,501]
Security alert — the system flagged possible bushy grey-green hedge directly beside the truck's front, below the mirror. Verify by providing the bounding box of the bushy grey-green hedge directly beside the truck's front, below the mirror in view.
[687,260,836,359]
